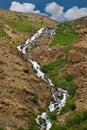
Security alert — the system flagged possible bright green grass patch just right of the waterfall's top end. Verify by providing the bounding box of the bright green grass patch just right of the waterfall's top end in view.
[49,22,78,47]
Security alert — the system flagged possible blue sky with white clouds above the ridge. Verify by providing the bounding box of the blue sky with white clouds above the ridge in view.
[0,0,87,22]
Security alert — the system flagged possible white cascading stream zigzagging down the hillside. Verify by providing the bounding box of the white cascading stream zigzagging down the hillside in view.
[17,27,67,130]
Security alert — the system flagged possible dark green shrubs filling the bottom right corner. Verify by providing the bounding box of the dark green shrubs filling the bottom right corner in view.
[50,110,87,130]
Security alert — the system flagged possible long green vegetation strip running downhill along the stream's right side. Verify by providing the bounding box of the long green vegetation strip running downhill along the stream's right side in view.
[41,22,87,130]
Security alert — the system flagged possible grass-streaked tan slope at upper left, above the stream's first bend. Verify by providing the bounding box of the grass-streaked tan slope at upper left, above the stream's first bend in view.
[0,9,57,45]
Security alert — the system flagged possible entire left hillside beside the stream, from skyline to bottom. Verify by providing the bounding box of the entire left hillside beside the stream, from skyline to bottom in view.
[0,9,56,130]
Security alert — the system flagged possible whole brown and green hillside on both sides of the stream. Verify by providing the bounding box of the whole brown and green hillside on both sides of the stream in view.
[0,9,87,130]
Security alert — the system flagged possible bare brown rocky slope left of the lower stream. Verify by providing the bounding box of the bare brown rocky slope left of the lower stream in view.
[0,39,51,130]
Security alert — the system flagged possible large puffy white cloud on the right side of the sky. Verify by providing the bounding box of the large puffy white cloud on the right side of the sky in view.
[45,2,87,22]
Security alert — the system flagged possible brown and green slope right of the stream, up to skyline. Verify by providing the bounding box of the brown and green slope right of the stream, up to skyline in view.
[38,17,87,130]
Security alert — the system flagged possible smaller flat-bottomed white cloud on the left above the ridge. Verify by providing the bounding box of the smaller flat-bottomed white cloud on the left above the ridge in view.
[9,1,40,13]
